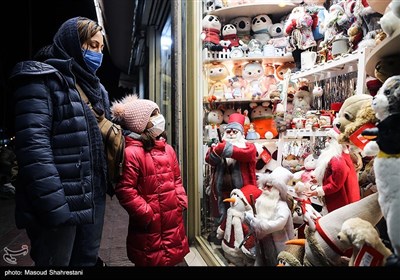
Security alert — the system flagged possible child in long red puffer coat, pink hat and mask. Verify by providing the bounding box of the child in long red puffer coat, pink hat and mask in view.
[111,95,189,266]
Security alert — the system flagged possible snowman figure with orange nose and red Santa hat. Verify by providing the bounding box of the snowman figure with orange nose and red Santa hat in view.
[217,185,262,266]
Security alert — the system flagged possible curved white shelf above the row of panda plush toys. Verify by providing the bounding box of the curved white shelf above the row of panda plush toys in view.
[209,0,301,22]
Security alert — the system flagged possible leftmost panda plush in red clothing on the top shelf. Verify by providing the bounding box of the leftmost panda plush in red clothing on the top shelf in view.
[200,15,223,51]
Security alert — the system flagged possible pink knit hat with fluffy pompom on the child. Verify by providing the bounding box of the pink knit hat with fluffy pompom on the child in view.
[111,94,160,134]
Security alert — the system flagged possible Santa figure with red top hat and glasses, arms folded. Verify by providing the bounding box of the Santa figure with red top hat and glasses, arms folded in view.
[205,113,257,225]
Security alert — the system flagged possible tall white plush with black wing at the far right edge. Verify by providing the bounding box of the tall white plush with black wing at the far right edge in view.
[365,76,400,266]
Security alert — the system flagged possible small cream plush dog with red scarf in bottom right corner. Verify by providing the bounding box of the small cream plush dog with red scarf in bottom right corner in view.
[337,217,392,266]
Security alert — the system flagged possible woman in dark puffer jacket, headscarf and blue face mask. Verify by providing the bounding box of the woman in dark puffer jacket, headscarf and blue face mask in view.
[11,17,110,266]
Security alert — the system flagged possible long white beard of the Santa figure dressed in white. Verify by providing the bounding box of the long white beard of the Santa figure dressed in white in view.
[255,187,280,219]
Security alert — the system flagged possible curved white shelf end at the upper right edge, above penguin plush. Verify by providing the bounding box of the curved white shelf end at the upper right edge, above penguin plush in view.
[365,28,400,77]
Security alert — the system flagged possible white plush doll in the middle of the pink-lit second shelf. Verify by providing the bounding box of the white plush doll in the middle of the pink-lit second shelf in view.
[242,61,265,99]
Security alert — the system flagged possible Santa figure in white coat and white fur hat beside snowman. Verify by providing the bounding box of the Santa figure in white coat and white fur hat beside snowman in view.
[245,166,294,266]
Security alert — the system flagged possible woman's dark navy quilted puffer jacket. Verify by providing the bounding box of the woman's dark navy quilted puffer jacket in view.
[11,59,109,228]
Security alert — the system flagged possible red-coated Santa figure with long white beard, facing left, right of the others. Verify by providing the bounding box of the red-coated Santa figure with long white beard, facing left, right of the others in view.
[305,127,360,214]
